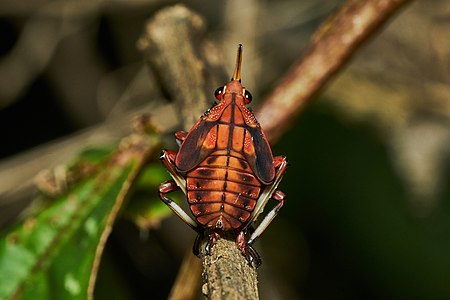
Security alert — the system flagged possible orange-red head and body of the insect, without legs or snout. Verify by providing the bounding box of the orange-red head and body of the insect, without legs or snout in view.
[182,80,275,230]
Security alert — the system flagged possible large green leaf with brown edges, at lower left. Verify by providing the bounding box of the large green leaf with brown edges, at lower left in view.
[0,136,157,299]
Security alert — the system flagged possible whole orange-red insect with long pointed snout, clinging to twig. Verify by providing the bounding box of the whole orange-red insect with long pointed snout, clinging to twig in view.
[159,44,288,266]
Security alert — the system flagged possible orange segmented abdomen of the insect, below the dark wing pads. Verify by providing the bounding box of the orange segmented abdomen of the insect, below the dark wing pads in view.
[186,124,262,230]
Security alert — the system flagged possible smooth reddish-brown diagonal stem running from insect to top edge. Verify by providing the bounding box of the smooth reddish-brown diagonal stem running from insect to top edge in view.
[257,0,410,141]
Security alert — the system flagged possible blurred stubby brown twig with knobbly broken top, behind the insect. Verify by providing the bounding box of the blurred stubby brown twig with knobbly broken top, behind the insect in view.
[138,5,207,129]
